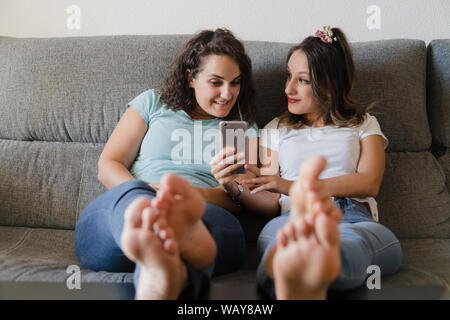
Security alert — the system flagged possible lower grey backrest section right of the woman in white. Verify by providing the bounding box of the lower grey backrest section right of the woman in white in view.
[376,151,450,239]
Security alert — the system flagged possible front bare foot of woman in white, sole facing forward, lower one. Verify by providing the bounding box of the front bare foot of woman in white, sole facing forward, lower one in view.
[273,213,341,300]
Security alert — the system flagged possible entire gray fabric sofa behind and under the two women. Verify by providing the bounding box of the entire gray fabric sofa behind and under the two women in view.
[0,35,450,299]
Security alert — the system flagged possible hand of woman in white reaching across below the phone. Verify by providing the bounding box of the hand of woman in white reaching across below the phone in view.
[242,165,294,195]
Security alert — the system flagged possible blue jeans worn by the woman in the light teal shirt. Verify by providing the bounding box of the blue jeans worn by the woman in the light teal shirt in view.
[74,180,245,299]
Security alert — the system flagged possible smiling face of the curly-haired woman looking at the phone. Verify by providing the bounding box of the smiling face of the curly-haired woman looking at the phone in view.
[188,55,241,119]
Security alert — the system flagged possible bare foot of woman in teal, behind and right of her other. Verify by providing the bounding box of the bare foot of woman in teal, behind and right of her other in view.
[152,173,217,269]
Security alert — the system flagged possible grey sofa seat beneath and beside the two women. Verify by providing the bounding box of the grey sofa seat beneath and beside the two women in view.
[0,226,450,292]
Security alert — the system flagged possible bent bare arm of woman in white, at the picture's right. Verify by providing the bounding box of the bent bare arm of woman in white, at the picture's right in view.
[322,135,386,197]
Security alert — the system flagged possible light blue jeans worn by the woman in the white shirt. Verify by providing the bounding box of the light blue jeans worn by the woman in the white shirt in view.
[257,198,402,298]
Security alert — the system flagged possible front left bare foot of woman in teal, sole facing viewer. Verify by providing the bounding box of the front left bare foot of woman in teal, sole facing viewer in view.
[121,197,187,300]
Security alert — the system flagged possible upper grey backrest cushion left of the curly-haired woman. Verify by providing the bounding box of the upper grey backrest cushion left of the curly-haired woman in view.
[0,36,186,143]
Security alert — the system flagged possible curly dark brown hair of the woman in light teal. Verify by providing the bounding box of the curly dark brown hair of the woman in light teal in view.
[161,29,255,123]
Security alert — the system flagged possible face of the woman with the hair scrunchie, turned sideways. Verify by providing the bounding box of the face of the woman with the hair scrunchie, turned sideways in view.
[284,50,321,122]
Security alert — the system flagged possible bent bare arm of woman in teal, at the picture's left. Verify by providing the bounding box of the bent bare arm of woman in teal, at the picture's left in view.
[98,107,148,189]
